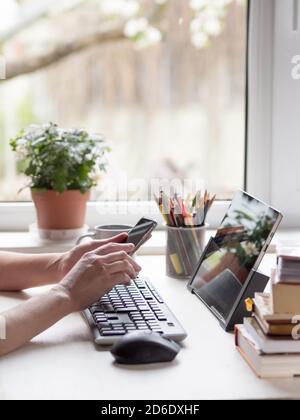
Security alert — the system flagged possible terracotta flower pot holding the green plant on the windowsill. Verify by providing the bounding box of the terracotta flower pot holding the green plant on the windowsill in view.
[31,189,90,230]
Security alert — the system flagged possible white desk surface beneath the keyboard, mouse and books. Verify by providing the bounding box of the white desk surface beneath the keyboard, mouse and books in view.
[0,255,300,400]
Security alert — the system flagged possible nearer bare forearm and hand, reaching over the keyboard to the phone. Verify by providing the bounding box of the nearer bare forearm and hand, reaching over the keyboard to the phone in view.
[0,238,141,356]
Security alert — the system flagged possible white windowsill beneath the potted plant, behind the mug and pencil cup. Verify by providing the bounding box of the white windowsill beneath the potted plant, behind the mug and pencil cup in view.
[0,229,300,255]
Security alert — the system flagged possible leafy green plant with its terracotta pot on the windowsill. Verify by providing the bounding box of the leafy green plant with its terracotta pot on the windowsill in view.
[10,123,109,230]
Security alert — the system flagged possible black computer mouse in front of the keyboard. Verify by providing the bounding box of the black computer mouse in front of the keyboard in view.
[111,332,181,365]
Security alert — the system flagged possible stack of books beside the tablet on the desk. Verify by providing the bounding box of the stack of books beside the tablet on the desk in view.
[235,251,300,378]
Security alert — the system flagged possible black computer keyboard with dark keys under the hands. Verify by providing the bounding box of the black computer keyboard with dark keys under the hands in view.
[84,278,186,344]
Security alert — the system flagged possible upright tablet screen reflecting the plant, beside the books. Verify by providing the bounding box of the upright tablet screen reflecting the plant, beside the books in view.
[191,191,281,319]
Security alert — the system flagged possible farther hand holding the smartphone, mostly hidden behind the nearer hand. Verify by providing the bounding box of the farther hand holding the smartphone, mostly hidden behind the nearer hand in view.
[57,233,128,280]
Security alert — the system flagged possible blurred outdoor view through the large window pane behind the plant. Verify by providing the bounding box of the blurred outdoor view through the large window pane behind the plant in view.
[0,0,247,201]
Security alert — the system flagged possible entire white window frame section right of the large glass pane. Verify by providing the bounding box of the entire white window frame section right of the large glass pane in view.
[247,0,300,228]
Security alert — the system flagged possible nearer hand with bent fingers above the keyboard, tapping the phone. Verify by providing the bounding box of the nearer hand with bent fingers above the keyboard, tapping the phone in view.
[54,240,141,312]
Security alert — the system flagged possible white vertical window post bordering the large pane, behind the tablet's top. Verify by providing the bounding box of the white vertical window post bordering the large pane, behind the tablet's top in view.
[245,0,275,203]
